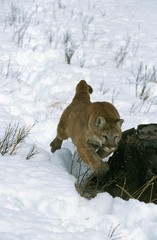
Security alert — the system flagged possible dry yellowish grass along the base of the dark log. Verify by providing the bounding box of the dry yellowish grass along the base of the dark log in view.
[76,167,157,203]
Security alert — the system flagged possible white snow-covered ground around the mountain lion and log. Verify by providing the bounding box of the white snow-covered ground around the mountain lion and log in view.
[0,0,157,240]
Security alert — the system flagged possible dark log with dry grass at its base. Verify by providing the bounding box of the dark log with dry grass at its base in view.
[79,124,157,203]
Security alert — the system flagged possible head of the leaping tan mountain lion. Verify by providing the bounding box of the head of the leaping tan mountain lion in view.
[88,103,124,156]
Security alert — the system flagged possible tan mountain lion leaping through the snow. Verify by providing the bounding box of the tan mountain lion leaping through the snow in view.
[50,80,123,172]
